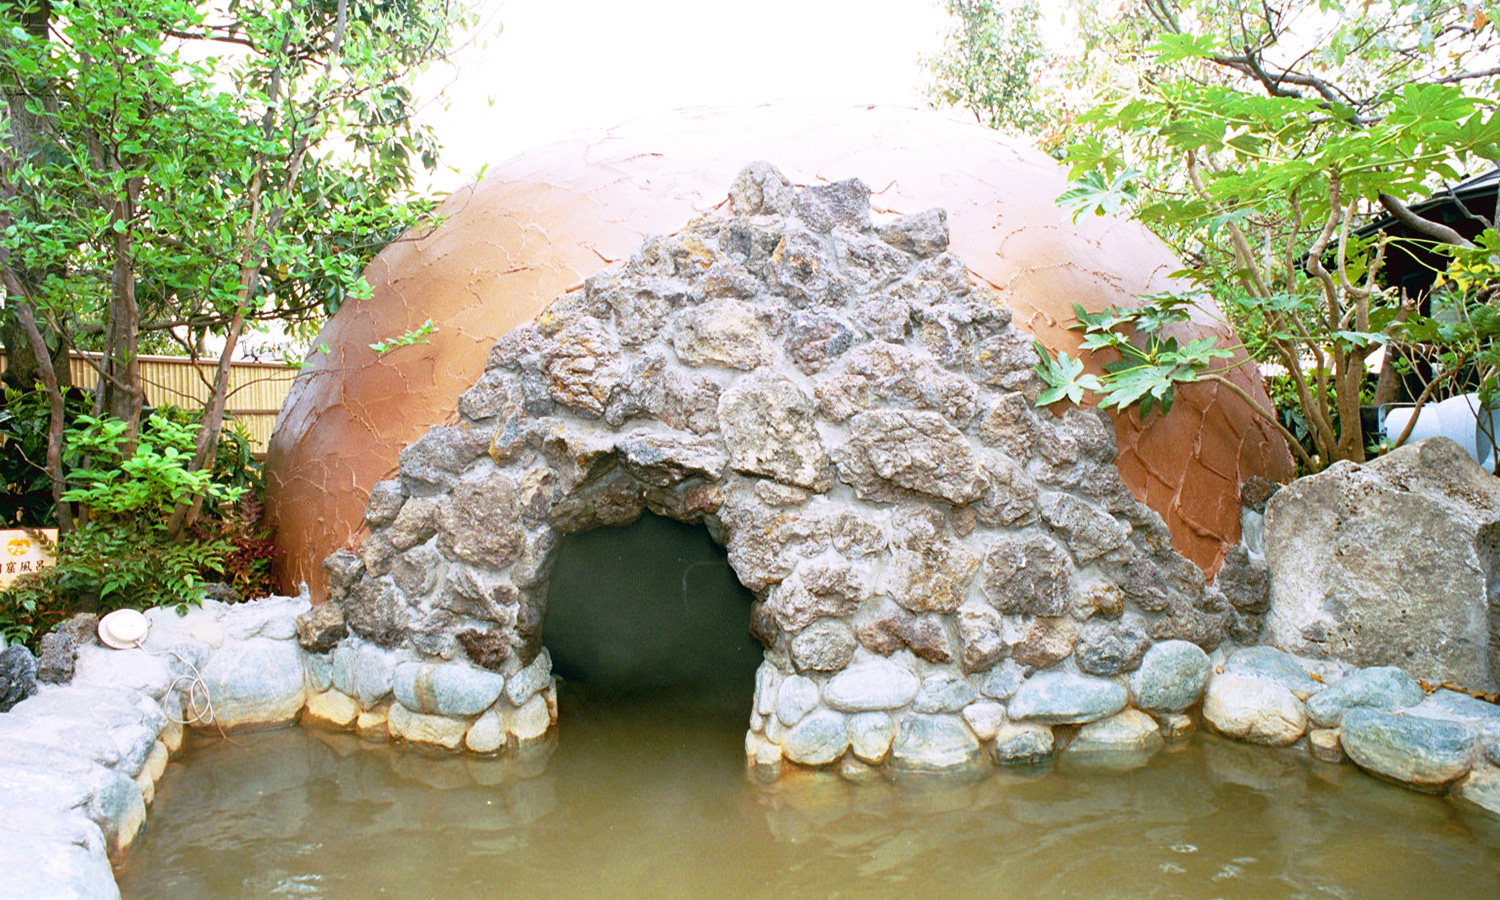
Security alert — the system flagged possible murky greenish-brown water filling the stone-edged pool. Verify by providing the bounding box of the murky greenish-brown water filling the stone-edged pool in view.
[120,693,1500,900]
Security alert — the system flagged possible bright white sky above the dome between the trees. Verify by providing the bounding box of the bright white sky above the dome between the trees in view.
[420,0,947,191]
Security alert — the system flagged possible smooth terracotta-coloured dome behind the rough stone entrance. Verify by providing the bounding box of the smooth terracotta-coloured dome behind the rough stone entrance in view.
[266,105,1292,602]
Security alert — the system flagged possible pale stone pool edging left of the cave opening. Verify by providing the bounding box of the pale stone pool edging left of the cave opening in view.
[0,597,557,900]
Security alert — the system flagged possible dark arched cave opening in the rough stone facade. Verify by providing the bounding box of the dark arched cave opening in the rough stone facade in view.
[542,513,764,726]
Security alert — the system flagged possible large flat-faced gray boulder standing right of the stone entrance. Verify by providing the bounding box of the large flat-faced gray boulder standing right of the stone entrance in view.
[1266,438,1500,690]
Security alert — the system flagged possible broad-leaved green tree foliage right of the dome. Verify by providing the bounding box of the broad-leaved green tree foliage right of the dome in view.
[1059,0,1500,470]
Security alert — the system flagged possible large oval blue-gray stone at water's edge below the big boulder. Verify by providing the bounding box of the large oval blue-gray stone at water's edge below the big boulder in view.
[1344,708,1478,792]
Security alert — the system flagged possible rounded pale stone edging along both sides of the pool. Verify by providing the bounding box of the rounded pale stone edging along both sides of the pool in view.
[0,597,1500,900]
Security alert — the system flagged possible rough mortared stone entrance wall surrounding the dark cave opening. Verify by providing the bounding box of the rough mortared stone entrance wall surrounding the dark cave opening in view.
[327,164,1236,768]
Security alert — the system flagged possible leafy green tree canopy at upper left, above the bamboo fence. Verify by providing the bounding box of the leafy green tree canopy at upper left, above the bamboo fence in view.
[0,0,459,344]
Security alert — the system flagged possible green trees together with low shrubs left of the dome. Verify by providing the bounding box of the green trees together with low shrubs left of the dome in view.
[0,0,471,642]
